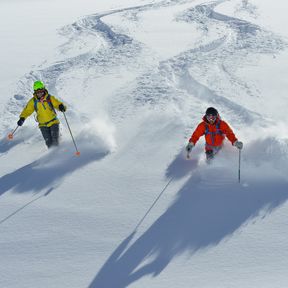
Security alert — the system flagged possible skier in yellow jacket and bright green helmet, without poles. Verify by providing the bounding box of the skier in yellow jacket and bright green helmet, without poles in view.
[17,81,66,148]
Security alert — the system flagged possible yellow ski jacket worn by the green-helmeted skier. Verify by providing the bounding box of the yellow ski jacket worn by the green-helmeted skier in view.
[20,93,64,127]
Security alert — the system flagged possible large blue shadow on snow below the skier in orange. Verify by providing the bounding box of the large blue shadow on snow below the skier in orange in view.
[89,168,288,288]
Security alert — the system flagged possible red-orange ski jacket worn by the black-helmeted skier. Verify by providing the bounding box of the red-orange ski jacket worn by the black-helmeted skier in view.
[189,116,237,150]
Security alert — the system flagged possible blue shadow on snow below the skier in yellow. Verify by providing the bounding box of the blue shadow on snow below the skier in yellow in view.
[0,148,108,196]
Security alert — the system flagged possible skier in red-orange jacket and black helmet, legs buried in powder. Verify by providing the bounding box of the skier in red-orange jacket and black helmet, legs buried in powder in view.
[186,107,243,160]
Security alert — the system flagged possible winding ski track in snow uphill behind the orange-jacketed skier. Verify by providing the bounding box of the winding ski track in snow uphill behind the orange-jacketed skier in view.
[172,1,287,125]
